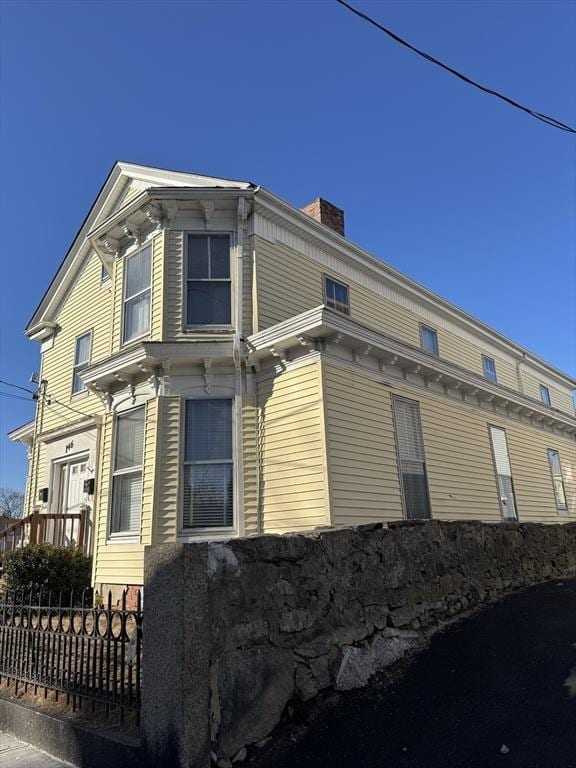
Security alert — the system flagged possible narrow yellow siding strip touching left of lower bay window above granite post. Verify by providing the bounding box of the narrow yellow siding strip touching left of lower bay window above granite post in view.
[155,397,180,544]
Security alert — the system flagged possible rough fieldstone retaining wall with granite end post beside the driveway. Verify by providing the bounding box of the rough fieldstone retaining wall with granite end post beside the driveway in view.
[143,521,576,768]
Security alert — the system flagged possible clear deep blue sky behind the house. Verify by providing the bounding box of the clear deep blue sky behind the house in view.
[0,0,576,488]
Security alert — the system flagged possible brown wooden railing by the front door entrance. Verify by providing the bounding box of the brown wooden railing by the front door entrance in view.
[0,508,89,552]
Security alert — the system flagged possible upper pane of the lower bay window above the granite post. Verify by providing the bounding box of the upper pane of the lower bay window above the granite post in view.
[185,400,232,461]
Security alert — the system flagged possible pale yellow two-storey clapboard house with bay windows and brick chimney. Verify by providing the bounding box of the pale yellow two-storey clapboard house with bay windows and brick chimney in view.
[10,163,576,592]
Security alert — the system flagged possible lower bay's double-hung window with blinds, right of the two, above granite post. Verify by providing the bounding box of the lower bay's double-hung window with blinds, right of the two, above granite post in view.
[182,399,234,529]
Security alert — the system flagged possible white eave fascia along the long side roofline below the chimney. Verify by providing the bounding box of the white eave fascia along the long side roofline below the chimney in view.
[255,187,576,388]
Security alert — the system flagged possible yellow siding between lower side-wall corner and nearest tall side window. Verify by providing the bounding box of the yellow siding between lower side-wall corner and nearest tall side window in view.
[322,364,403,526]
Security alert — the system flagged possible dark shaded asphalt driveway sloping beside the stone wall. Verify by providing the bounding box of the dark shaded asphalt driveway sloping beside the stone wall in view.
[251,579,576,768]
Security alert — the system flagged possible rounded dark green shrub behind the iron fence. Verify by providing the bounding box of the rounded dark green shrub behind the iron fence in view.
[3,544,92,601]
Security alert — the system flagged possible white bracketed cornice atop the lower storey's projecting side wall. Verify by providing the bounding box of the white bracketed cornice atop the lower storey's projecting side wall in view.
[246,306,576,428]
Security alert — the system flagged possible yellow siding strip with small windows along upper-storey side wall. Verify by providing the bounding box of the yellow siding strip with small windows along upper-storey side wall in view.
[254,238,518,391]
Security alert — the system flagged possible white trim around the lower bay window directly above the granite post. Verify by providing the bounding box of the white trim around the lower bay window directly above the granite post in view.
[177,395,236,542]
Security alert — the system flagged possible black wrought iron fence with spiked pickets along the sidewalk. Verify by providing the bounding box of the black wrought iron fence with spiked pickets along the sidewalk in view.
[0,591,143,720]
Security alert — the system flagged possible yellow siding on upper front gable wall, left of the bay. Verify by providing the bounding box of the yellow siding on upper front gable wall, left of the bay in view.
[41,253,112,432]
